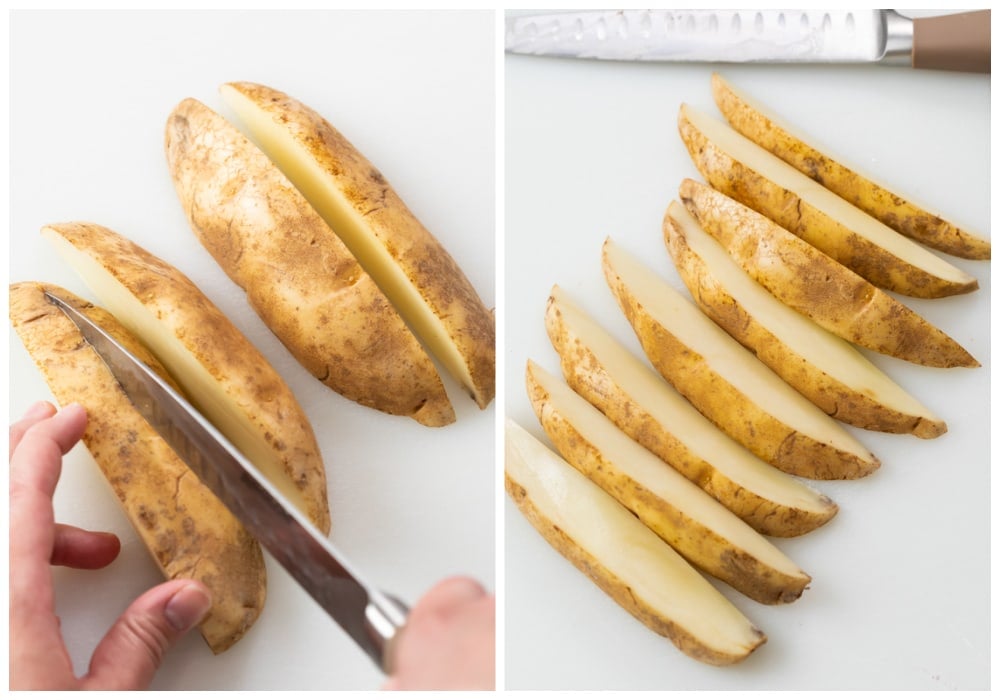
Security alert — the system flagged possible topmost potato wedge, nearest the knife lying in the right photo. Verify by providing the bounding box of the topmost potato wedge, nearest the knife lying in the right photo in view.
[712,73,990,260]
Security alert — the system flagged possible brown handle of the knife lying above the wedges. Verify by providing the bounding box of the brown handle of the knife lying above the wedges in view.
[913,10,990,73]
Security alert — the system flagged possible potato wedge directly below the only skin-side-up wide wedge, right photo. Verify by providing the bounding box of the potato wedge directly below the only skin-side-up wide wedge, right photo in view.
[663,202,947,438]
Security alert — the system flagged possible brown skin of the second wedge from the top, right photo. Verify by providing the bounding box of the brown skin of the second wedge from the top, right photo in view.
[678,107,979,299]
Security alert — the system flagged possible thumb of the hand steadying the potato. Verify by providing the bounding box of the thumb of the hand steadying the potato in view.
[83,579,212,690]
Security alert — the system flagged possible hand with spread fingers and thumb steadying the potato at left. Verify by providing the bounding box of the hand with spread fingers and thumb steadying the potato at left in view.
[10,402,211,690]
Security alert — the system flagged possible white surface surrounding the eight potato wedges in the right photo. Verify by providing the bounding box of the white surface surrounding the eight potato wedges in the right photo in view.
[504,21,990,690]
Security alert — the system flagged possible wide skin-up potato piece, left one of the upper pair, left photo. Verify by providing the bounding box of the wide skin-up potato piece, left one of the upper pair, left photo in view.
[165,99,455,426]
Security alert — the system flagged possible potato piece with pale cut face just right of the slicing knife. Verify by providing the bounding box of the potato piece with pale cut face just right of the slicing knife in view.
[42,223,330,532]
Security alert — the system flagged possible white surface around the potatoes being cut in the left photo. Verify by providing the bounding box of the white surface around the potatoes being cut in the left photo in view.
[9,11,496,690]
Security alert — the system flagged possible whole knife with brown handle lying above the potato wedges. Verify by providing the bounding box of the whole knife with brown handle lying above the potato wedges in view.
[505,10,990,73]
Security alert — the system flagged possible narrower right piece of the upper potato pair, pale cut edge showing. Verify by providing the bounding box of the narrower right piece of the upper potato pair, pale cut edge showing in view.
[222,83,496,408]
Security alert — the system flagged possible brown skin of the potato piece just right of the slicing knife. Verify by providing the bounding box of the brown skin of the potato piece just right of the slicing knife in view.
[45,222,330,533]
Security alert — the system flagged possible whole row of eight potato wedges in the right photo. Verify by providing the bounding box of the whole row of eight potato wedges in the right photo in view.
[506,74,990,665]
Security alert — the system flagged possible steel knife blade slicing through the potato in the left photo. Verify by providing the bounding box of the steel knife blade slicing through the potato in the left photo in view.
[45,291,408,673]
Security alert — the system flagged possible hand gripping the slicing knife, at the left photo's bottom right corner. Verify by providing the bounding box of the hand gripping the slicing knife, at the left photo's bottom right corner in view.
[383,577,496,690]
